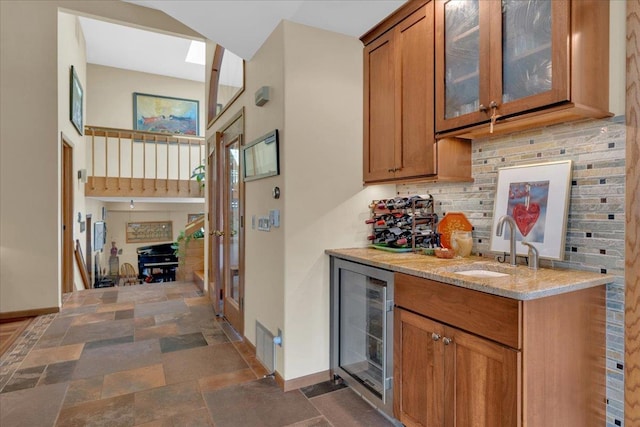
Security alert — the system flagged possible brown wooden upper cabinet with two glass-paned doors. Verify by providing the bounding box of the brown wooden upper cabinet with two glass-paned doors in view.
[435,0,611,138]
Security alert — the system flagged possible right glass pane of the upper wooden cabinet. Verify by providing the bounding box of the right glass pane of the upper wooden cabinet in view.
[502,0,552,103]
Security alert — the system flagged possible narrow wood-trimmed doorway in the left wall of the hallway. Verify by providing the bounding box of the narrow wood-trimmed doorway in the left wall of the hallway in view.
[60,136,74,294]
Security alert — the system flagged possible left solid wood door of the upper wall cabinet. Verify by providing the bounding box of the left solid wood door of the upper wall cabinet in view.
[364,32,396,181]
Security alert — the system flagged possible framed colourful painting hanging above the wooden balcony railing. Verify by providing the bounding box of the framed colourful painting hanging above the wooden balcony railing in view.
[133,92,200,136]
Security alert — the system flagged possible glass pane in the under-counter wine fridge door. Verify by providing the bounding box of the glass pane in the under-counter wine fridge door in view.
[339,270,386,397]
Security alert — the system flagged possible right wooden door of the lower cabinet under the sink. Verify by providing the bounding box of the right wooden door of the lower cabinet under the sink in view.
[443,328,521,427]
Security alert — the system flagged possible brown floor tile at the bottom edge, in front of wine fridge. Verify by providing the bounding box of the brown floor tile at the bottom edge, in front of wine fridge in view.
[309,388,393,427]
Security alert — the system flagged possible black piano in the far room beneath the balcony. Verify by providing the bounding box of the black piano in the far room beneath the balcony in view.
[136,243,178,283]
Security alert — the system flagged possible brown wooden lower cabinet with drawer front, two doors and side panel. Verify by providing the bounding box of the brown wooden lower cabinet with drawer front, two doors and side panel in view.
[394,273,605,427]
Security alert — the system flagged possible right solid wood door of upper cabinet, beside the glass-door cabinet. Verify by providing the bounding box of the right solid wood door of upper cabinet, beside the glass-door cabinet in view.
[395,3,436,178]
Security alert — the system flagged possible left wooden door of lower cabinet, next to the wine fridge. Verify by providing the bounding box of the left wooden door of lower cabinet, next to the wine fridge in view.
[394,308,444,427]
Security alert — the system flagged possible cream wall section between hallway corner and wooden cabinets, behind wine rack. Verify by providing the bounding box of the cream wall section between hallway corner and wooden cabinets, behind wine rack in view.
[283,22,395,380]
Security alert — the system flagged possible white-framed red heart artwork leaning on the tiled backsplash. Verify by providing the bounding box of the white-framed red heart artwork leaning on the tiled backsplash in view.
[490,160,572,260]
